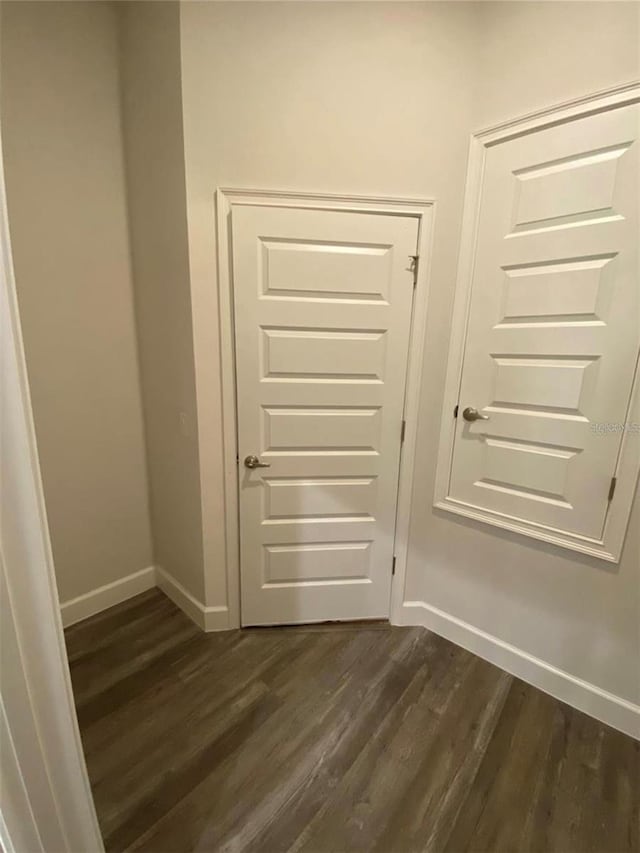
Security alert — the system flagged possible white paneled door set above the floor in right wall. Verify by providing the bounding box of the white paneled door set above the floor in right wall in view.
[449,105,640,540]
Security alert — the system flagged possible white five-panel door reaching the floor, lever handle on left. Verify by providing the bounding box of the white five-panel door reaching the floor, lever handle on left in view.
[232,205,418,625]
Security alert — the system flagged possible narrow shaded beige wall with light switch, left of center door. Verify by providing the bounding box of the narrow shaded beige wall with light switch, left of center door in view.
[119,2,204,601]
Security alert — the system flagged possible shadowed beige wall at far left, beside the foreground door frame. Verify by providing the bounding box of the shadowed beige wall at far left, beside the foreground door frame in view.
[1,2,152,601]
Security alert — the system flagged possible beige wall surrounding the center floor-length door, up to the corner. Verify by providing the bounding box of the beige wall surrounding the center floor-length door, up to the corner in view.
[181,2,477,605]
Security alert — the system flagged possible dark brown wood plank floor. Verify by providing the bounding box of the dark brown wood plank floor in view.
[66,590,640,853]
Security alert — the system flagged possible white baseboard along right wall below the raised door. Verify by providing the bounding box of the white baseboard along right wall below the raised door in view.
[394,601,640,740]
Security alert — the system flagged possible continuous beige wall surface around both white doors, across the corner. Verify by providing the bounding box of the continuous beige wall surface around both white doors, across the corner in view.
[181,2,640,701]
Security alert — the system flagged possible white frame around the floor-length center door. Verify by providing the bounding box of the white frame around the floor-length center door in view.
[215,188,435,628]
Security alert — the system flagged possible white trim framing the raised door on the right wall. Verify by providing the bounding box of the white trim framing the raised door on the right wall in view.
[434,82,640,563]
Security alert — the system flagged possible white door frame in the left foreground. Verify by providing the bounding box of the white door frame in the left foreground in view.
[0,138,104,853]
